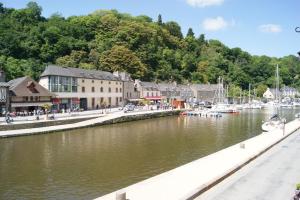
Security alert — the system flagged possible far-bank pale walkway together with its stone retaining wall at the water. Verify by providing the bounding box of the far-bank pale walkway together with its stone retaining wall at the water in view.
[0,110,181,138]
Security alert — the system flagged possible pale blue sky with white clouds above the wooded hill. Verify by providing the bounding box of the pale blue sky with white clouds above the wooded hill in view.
[1,0,300,57]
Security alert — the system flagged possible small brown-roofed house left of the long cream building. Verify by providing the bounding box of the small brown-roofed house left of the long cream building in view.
[8,77,54,112]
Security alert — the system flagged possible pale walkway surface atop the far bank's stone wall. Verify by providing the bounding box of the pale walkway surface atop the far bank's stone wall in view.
[0,110,178,138]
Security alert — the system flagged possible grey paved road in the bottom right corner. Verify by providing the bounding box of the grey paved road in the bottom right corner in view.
[196,131,300,200]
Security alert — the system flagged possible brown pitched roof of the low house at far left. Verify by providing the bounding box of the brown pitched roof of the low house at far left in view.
[8,76,55,97]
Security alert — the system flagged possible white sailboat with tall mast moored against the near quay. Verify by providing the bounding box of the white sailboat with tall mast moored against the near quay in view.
[261,65,285,132]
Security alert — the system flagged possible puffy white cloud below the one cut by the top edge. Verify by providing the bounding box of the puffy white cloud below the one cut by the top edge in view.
[202,17,235,31]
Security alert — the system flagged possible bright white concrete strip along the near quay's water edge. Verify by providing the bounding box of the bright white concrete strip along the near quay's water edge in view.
[97,119,300,200]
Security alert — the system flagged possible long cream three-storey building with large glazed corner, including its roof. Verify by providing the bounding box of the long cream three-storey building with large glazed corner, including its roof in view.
[39,65,123,110]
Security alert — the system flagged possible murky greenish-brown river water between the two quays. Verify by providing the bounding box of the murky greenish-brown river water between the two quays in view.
[0,109,299,200]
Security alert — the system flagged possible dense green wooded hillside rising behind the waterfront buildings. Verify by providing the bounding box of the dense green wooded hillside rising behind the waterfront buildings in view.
[0,2,300,96]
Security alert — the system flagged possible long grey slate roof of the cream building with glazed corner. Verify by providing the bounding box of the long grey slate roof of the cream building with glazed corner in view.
[41,65,121,81]
